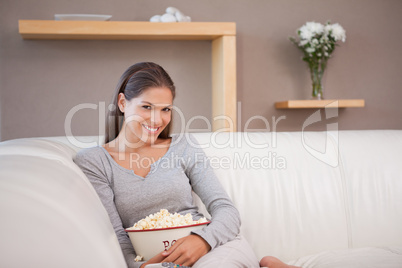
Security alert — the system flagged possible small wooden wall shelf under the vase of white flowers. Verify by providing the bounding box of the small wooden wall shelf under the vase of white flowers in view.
[275,99,365,109]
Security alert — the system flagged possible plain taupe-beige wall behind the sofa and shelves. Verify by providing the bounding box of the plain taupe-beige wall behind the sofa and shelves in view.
[0,0,402,140]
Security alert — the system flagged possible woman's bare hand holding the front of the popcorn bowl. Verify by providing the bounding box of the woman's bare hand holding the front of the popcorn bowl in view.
[162,234,211,266]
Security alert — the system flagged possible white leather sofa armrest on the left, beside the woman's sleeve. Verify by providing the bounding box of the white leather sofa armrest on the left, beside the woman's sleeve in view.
[0,139,126,268]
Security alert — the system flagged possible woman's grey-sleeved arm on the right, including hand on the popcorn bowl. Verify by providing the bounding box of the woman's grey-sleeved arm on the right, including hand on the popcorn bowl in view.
[162,136,240,266]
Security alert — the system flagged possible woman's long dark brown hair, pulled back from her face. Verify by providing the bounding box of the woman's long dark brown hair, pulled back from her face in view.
[105,62,176,144]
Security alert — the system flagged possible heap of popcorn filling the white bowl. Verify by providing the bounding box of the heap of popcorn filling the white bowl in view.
[127,209,207,230]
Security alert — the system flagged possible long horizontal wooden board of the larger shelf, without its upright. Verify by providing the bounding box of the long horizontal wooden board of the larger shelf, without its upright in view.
[19,20,236,40]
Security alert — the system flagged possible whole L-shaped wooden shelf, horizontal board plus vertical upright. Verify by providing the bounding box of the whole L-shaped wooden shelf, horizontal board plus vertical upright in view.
[19,20,237,131]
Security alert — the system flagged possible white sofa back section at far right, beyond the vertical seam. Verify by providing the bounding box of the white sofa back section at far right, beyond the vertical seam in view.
[339,130,402,249]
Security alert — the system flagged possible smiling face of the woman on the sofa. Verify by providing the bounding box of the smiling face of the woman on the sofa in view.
[119,87,173,144]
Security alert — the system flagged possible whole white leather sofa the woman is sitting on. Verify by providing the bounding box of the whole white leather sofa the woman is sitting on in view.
[0,130,402,268]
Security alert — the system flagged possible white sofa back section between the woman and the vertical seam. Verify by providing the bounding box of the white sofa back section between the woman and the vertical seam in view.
[194,132,348,261]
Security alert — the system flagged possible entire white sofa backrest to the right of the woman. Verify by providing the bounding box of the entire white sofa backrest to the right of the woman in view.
[191,130,402,261]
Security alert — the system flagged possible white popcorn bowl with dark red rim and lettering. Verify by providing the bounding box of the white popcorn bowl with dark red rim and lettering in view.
[126,221,210,261]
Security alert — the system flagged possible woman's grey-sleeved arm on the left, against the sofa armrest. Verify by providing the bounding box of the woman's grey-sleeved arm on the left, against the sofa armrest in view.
[74,149,142,268]
